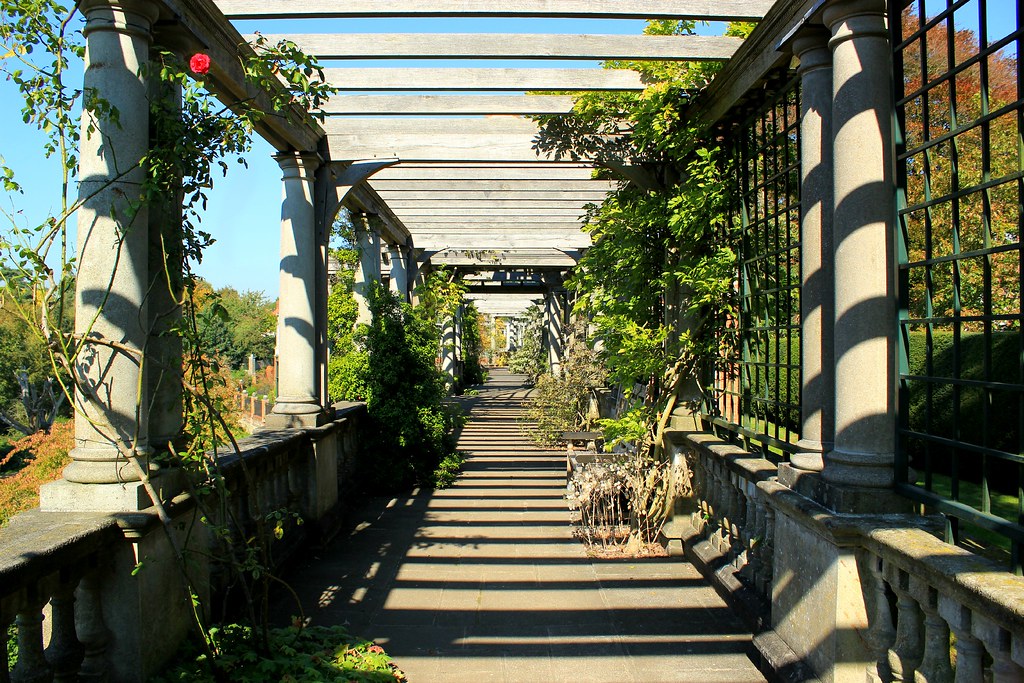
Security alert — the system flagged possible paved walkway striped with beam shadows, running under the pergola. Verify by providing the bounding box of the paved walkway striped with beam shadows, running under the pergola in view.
[276,371,764,683]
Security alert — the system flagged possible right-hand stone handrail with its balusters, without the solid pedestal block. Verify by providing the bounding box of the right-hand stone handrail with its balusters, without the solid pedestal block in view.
[672,432,1024,683]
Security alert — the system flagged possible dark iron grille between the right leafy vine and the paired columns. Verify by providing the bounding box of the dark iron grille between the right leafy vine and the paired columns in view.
[705,73,801,461]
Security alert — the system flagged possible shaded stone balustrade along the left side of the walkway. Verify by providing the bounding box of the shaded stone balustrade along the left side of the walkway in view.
[0,403,365,683]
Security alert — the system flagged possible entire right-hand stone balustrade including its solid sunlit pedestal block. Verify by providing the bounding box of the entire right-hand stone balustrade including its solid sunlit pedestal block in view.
[671,432,1024,683]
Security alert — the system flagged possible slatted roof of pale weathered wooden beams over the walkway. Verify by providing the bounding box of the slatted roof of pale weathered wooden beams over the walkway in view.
[207,0,773,315]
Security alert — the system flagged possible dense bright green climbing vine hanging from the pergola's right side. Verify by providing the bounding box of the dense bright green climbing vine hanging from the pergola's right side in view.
[536,22,751,542]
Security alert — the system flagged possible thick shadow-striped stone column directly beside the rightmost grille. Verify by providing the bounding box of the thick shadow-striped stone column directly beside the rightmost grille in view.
[823,0,897,511]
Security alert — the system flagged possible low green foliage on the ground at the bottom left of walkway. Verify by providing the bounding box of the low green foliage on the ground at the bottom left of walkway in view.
[151,624,406,683]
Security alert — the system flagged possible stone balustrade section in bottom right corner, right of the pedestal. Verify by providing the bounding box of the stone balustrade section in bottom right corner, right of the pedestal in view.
[858,528,1024,683]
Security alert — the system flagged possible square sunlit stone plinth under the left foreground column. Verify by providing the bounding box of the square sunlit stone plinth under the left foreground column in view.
[39,469,183,512]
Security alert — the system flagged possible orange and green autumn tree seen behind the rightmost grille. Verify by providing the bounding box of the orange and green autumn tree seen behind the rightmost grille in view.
[901,6,1020,331]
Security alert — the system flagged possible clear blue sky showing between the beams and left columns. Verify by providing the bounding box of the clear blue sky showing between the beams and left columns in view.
[0,0,1015,298]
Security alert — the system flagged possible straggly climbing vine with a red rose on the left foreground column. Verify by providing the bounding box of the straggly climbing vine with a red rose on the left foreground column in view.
[0,0,374,678]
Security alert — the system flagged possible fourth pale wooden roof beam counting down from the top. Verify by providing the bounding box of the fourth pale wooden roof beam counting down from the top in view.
[322,95,572,116]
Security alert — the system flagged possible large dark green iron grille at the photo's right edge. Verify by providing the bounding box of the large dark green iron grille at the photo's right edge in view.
[890,0,1024,571]
